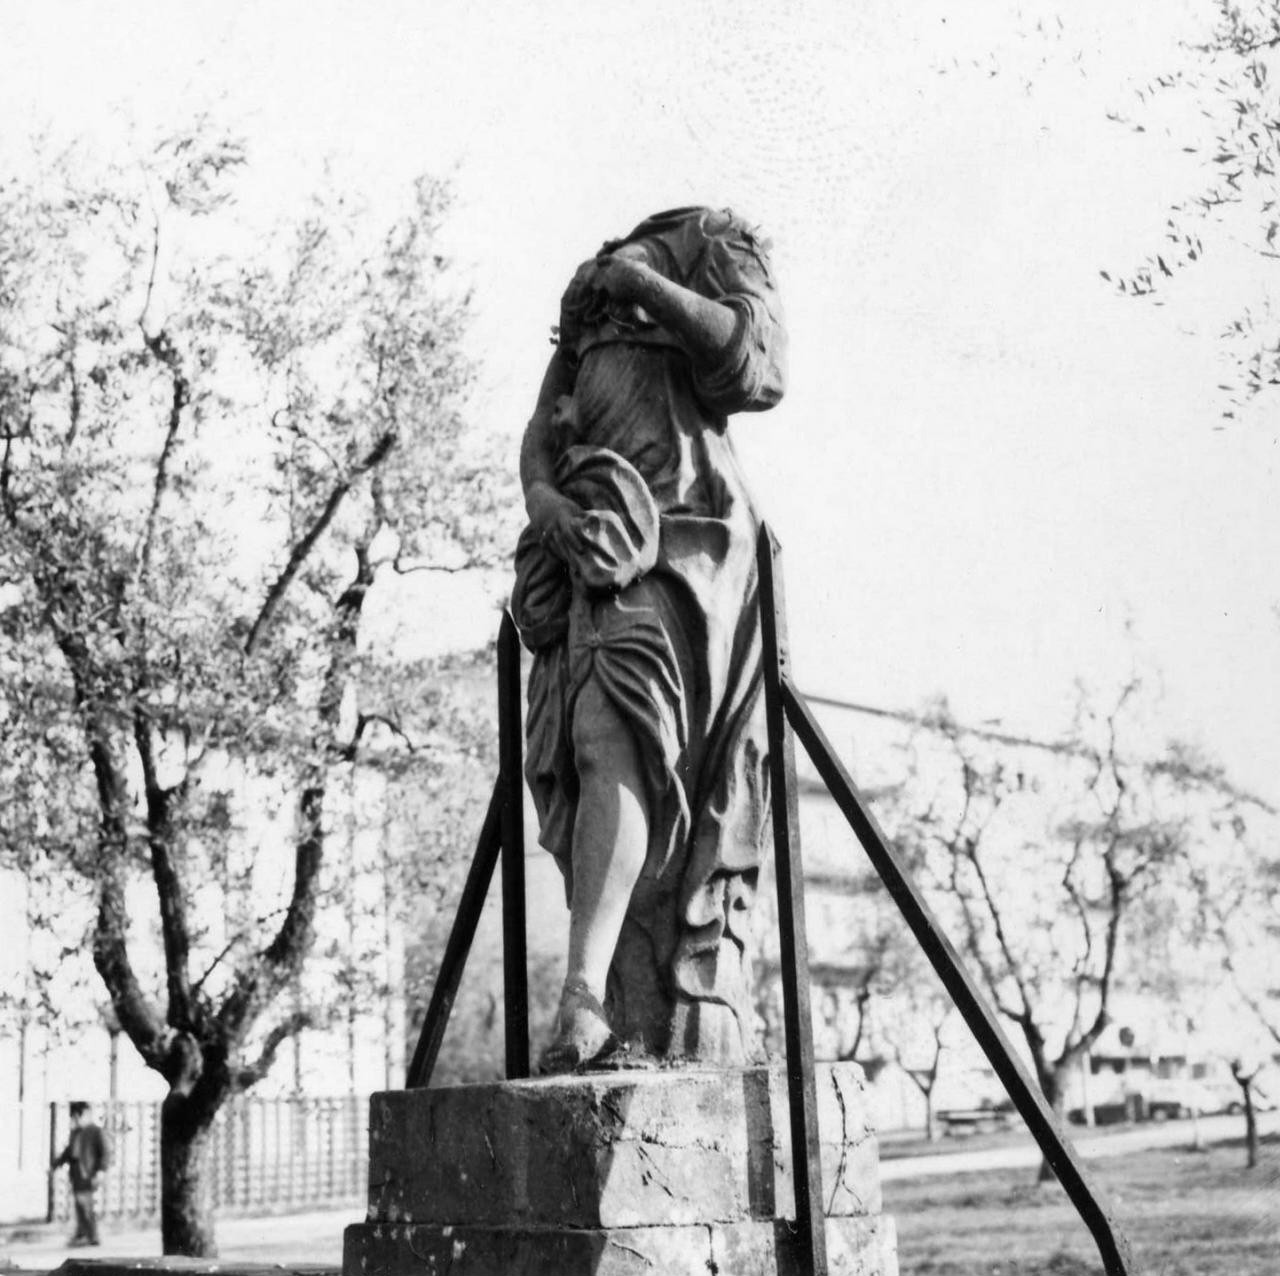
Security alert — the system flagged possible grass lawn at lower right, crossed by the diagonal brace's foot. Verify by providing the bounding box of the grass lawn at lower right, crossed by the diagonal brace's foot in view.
[884,1140,1280,1276]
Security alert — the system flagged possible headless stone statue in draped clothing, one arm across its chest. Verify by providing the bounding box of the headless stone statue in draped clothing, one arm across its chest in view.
[512,207,786,1073]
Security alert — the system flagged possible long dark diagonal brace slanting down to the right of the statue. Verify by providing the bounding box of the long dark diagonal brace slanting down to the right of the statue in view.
[781,676,1133,1276]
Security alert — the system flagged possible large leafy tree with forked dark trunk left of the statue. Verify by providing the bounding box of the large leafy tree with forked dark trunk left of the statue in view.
[0,125,500,1256]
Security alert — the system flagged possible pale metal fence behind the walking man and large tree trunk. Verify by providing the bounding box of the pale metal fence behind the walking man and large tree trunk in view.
[47,1094,369,1222]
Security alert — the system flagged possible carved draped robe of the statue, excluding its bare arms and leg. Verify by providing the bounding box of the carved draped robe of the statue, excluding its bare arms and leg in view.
[512,209,786,1062]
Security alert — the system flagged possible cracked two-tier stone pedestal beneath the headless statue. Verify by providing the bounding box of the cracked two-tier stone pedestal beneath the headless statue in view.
[343,1065,897,1276]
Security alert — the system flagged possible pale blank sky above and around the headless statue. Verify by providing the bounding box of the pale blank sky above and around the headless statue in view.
[0,0,1280,802]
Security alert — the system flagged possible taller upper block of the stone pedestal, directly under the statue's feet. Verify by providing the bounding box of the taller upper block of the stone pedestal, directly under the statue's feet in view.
[369,1065,881,1229]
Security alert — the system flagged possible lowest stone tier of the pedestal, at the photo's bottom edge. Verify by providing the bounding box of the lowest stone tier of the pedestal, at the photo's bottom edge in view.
[343,1217,897,1276]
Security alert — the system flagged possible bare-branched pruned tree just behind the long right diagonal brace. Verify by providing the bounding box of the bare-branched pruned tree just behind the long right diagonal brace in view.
[895,683,1187,1177]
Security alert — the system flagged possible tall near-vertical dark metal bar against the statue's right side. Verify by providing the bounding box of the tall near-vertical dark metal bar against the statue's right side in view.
[756,527,827,1276]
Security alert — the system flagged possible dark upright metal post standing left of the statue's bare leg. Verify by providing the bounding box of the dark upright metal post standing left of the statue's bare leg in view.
[498,612,529,1079]
